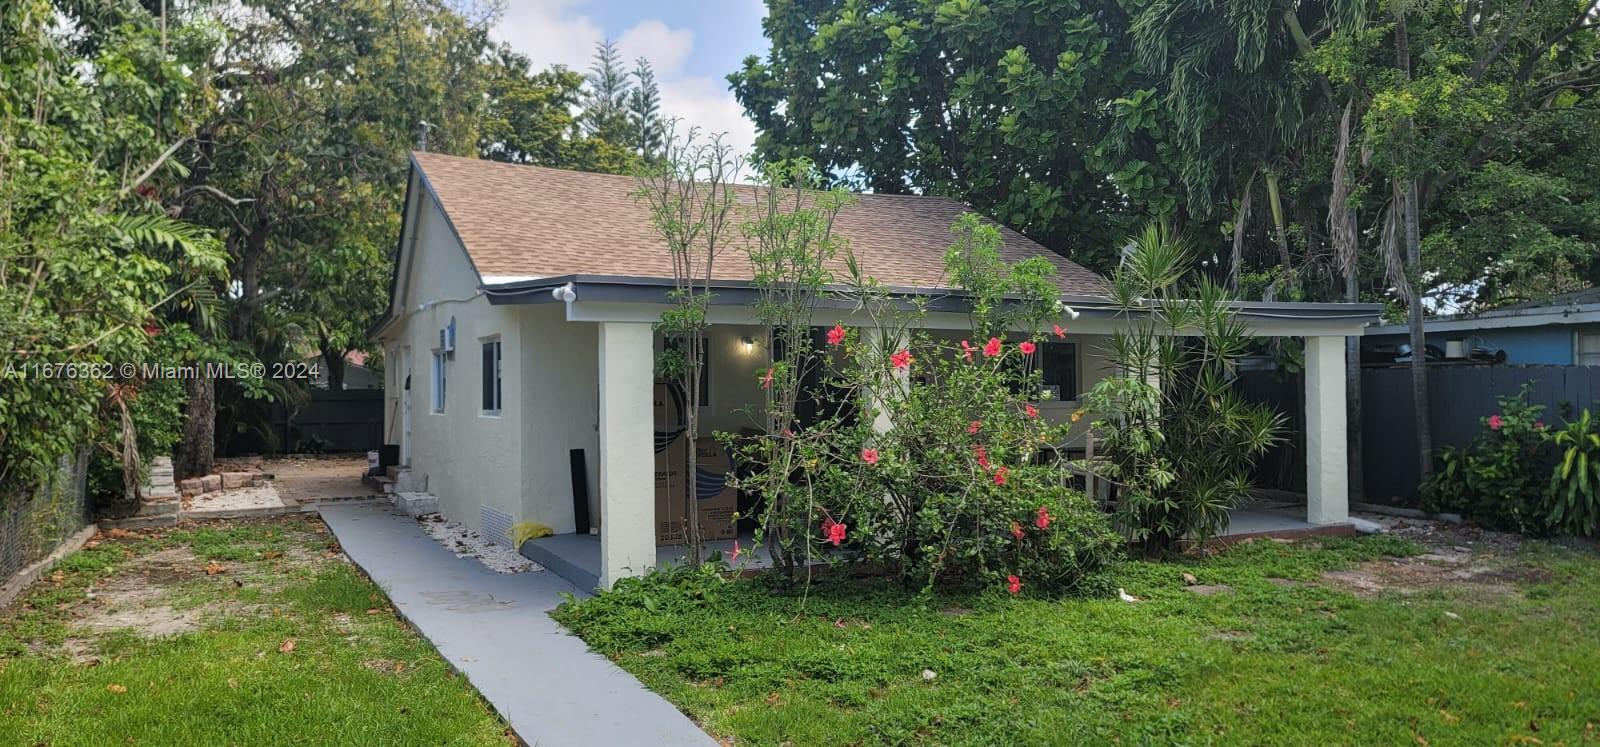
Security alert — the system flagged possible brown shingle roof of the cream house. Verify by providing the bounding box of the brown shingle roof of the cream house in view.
[413,152,1104,294]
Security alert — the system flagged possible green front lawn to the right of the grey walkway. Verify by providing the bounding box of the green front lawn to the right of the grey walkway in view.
[557,537,1600,745]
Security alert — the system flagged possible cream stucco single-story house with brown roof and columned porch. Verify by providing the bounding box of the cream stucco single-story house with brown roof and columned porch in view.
[374,152,1379,587]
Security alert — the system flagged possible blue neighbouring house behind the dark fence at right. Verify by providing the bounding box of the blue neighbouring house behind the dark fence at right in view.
[1362,288,1600,366]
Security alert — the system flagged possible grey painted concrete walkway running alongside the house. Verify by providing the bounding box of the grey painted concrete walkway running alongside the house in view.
[322,502,717,747]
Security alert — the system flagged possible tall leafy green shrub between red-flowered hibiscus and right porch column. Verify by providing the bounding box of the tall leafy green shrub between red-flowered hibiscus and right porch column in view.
[1083,226,1283,553]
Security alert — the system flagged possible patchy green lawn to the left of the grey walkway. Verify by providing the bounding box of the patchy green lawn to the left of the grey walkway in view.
[0,518,507,745]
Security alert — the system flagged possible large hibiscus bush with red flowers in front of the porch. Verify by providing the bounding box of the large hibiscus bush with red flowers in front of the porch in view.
[738,209,1118,593]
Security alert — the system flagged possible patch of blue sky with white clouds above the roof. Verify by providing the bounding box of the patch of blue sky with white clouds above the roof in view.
[494,0,766,150]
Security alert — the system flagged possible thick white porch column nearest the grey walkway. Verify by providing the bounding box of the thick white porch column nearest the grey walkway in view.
[600,322,656,589]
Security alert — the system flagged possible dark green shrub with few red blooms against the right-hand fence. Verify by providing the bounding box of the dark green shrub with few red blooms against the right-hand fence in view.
[1421,385,1555,534]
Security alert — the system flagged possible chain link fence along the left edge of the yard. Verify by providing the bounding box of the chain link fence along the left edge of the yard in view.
[0,451,90,584]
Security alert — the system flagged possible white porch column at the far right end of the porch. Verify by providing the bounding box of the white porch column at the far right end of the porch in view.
[1306,336,1350,525]
